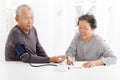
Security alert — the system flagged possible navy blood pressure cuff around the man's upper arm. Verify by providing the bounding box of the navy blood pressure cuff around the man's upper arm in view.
[15,42,27,58]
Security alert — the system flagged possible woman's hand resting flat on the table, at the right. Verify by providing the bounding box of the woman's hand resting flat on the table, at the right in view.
[83,60,104,68]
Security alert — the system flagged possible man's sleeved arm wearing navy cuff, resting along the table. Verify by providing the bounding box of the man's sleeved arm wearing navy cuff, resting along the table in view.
[15,42,50,63]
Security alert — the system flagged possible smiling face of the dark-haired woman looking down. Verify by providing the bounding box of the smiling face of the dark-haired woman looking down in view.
[78,20,93,41]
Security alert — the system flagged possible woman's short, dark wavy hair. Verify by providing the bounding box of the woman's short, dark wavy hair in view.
[77,14,97,29]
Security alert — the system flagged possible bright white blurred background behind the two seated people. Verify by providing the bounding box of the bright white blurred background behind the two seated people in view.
[0,0,120,61]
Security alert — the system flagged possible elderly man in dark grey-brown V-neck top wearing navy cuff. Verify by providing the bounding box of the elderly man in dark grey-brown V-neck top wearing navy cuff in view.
[5,5,65,63]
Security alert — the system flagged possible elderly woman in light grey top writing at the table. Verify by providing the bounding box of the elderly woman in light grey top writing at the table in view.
[66,14,116,68]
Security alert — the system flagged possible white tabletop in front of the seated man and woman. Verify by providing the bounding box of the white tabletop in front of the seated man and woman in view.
[0,61,120,80]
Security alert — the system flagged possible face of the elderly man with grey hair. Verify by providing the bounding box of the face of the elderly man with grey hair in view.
[16,9,34,31]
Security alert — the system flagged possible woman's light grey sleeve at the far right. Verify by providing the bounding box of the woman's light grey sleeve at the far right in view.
[98,40,117,65]
